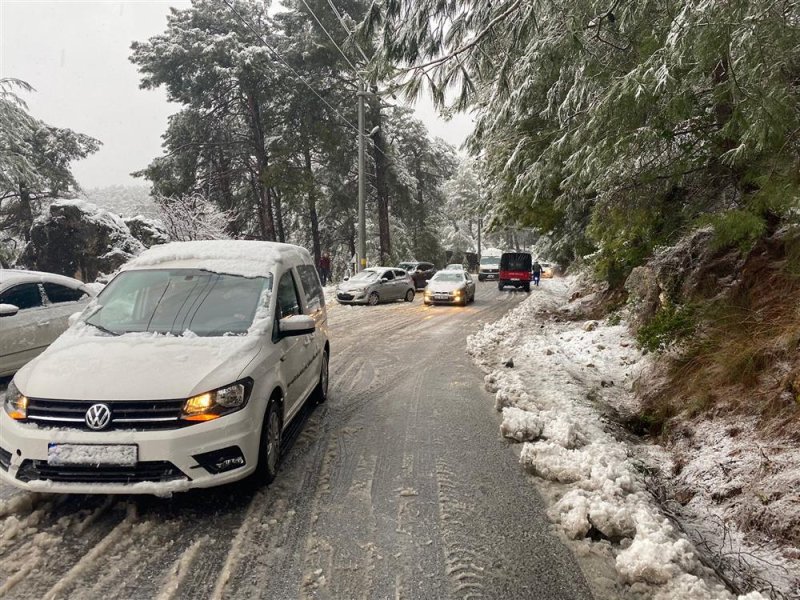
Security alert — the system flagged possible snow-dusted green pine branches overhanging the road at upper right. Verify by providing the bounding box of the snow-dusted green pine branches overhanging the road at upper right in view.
[361,0,800,283]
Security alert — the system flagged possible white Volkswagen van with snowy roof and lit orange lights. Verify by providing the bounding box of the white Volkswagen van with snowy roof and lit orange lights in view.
[0,240,330,494]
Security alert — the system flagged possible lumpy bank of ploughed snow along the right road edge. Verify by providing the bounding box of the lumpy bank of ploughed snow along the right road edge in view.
[467,279,776,600]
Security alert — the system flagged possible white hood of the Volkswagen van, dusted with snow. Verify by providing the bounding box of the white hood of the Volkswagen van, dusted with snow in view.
[14,334,262,400]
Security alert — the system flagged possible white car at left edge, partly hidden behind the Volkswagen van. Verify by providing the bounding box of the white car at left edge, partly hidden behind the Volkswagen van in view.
[0,269,97,377]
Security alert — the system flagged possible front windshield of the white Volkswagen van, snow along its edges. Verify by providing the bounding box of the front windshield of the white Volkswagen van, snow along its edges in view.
[85,269,272,337]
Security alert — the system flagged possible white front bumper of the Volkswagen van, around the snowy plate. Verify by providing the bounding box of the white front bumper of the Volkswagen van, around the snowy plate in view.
[0,405,262,496]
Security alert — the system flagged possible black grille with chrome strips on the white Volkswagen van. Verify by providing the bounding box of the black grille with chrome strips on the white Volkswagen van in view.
[27,398,187,431]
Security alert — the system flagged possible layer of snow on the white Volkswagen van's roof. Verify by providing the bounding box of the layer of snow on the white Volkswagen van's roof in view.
[122,240,313,277]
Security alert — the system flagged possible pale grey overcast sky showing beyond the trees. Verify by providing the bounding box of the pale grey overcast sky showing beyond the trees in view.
[0,0,472,188]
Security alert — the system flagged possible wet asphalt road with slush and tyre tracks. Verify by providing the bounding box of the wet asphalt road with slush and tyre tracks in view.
[0,283,590,600]
